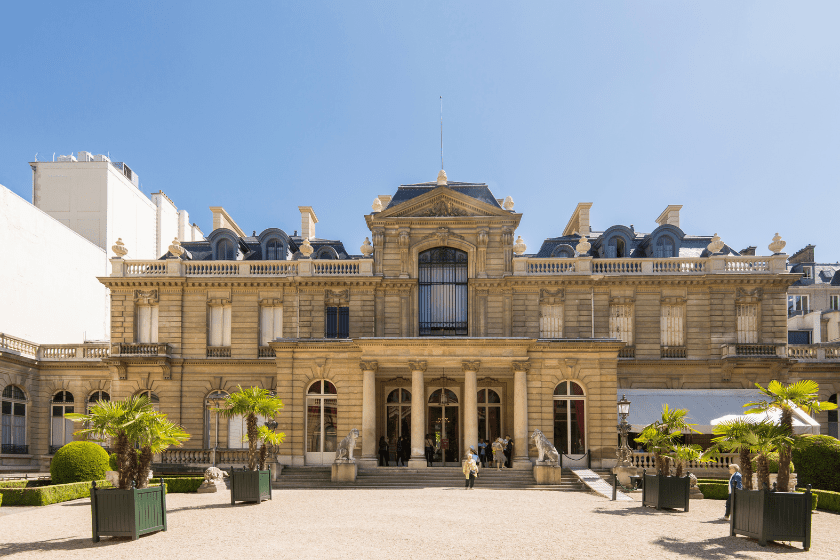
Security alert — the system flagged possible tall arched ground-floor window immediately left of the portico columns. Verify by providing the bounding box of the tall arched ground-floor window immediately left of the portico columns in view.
[306,380,338,465]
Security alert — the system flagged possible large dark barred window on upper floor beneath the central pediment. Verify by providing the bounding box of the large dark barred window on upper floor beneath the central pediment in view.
[418,247,468,336]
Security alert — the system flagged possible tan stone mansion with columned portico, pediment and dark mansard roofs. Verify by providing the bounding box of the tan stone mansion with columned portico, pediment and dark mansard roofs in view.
[0,172,840,468]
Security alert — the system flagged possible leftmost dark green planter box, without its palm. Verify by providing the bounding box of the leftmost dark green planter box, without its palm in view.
[90,479,166,542]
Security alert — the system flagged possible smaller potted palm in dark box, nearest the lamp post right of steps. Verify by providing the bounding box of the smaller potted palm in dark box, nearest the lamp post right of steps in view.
[636,404,698,511]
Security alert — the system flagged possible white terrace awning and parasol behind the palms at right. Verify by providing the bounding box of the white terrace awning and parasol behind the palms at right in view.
[617,389,820,434]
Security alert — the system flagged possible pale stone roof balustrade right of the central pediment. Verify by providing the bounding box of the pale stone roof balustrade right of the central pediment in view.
[513,254,787,276]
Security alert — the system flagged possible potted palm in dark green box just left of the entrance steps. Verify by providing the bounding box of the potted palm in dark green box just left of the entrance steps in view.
[219,385,285,504]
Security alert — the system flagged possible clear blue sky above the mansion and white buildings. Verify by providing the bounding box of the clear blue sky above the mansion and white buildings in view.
[0,0,840,262]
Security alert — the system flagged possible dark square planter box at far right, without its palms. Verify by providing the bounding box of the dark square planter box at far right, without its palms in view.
[729,485,811,550]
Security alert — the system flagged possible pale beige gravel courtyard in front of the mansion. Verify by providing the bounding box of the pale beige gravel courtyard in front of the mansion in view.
[0,487,840,560]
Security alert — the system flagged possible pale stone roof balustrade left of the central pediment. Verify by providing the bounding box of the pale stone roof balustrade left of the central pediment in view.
[111,259,373,277]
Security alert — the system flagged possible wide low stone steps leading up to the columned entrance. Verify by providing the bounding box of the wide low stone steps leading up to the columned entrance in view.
[272,467,584,491]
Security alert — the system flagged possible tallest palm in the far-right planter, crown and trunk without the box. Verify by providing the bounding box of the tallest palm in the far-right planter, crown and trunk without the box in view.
[744,379,837,492]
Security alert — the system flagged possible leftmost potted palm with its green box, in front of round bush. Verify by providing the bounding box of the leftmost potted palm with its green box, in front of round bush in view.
[65,396,190,542]
